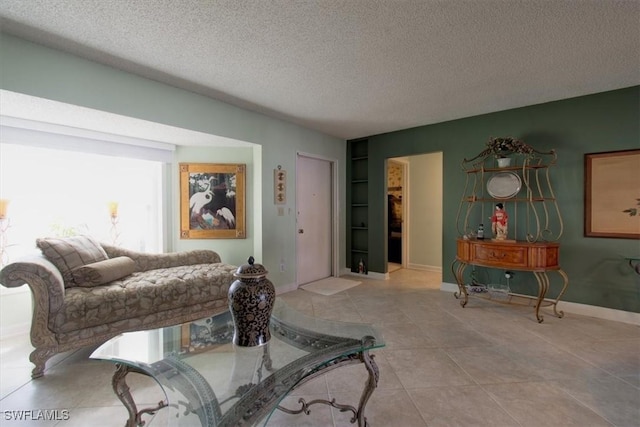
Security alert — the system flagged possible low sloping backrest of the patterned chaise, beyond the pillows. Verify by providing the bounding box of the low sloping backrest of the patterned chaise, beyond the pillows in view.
[100,243,222,271]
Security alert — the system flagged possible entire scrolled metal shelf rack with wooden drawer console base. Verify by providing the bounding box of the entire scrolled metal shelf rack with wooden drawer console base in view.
[451,137,569,322]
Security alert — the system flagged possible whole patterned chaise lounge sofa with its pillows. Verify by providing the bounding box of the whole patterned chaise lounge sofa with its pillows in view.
[0,236,237,378]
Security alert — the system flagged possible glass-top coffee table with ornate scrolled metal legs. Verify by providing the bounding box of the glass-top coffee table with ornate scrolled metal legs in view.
[91,300,384,427]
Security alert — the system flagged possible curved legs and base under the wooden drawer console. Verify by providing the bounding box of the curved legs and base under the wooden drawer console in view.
[451,260,569,323]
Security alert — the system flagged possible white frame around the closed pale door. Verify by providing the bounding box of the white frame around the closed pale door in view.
[295,151,340,286]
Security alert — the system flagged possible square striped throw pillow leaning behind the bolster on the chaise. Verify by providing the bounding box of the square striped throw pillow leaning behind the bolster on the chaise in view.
[36,236,109,287]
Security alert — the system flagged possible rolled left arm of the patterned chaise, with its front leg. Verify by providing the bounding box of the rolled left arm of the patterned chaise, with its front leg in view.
[0,255,65,345]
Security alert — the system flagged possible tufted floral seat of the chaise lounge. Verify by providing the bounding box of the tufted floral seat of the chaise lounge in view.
[50,263,236,334]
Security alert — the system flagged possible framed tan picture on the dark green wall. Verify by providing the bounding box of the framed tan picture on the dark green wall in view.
[584,150,640,239]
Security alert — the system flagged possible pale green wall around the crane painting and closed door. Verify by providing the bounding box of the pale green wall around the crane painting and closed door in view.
[0,34,346,287]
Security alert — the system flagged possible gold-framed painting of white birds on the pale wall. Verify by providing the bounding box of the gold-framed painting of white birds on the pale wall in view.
[179,163,246,239]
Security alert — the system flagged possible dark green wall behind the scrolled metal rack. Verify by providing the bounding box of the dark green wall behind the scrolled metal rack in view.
[369,87,640,312]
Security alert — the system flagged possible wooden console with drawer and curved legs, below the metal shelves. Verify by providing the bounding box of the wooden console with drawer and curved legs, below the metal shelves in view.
[451,239,569,322]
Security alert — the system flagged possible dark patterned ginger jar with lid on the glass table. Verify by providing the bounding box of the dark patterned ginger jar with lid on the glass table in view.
[229,257,276,347]
